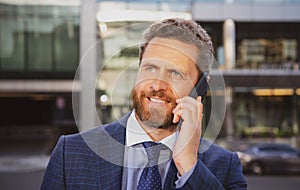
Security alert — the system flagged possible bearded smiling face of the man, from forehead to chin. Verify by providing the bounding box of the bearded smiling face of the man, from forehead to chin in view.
[132,38,198,128]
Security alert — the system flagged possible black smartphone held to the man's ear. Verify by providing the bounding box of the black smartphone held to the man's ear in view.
[177,72,208,131]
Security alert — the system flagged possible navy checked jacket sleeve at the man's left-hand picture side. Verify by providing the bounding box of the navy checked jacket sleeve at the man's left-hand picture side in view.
[41,136,65,190]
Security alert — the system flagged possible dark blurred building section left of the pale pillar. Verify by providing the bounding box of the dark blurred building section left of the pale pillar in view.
[0,0,80,151]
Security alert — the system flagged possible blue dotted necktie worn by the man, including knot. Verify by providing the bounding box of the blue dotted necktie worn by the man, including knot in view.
[137,142,162,190]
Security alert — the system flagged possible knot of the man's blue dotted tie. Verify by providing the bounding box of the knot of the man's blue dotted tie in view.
[142,141,163,167]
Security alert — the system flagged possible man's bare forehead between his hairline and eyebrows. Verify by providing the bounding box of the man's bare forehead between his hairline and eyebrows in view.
[142,37,198,69]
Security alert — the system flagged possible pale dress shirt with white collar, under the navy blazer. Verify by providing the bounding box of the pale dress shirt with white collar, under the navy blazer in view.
[122,111,193,190]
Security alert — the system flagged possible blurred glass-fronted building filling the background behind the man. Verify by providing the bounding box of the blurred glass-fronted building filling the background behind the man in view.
[0,0,300,151]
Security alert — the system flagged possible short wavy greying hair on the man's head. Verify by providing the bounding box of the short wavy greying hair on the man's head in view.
[139,18,214,72]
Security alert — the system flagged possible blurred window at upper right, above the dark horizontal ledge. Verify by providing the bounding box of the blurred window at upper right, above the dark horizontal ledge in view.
[237,38,297,69]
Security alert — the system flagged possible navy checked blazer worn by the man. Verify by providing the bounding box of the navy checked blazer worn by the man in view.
[41,114,247,190]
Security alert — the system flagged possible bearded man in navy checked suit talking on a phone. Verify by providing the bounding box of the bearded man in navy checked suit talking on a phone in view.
[41,19,247,190]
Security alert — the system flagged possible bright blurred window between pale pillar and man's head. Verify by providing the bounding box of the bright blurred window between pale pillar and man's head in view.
[97,22,146,123]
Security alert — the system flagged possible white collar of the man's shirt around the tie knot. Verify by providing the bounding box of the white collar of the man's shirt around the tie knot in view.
[126,110,178,150]
